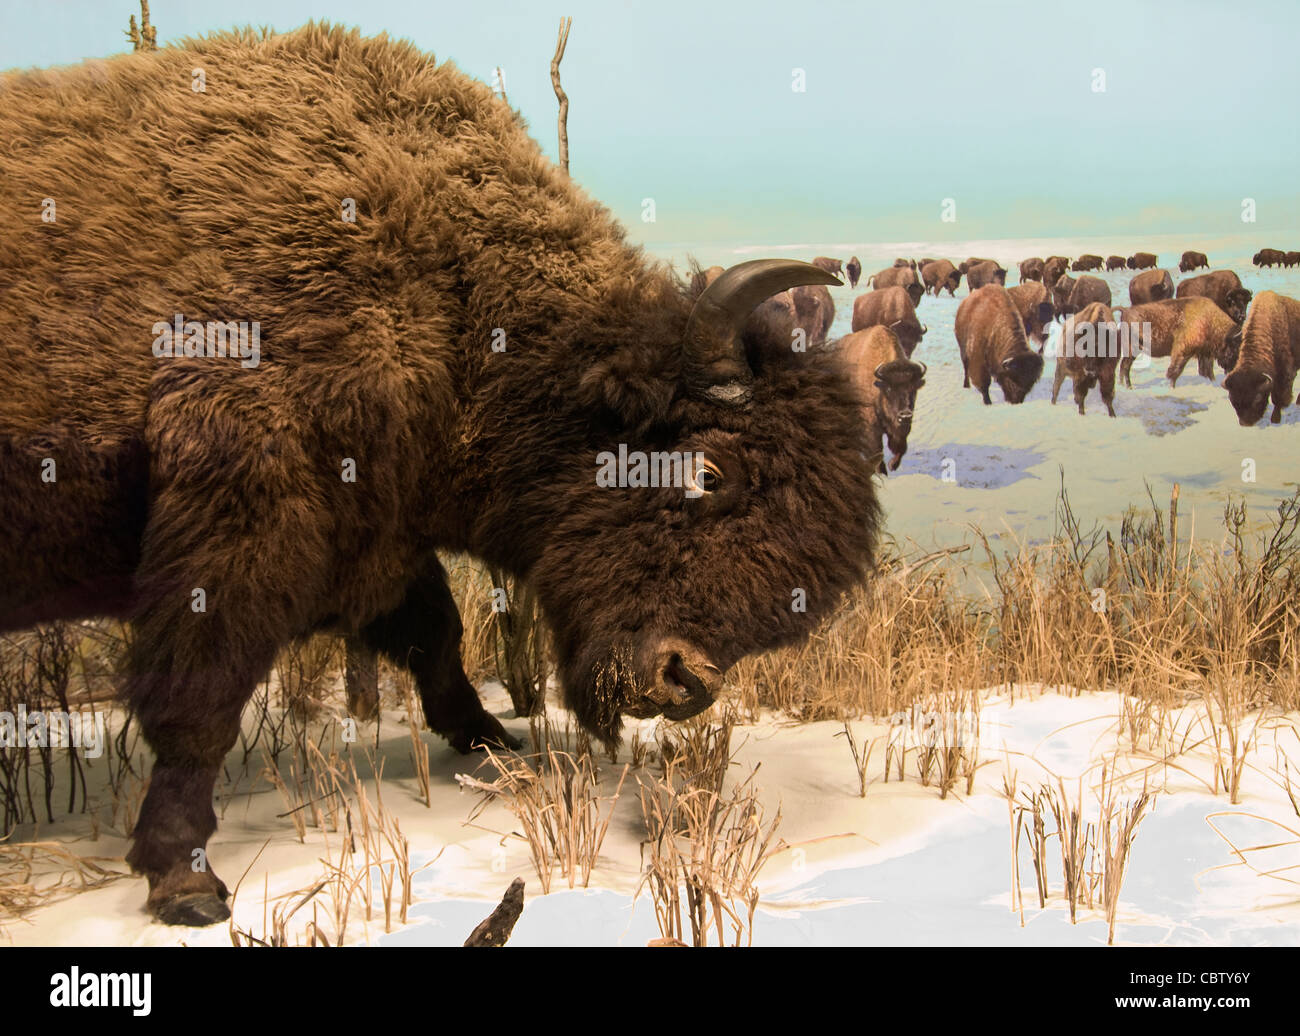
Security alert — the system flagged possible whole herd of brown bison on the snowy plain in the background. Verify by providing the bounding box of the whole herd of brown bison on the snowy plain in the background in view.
[733,248,1300,473]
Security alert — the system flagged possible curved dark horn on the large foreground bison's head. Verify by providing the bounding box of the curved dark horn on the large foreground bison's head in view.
[683,259,844,406]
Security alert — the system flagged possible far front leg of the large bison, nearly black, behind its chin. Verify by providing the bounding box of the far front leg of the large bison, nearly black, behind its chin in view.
[361,564,520,754]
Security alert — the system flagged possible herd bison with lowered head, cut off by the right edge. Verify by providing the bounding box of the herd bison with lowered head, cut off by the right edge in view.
[1223,291,1300,426]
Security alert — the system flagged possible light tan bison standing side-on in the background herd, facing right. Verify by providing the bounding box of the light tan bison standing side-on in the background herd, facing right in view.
[1114,295,1242,389]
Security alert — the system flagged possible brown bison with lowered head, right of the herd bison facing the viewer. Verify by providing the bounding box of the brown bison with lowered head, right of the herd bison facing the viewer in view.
[953,291,1043,406]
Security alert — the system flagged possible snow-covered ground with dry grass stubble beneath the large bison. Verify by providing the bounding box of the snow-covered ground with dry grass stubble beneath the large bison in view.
[0,684,1300,945]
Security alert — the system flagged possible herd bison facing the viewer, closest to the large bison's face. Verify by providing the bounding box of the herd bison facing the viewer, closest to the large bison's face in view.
[839,326,926,474]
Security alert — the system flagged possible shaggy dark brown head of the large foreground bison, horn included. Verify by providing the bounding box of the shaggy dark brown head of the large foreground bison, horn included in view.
[517,260,879,744]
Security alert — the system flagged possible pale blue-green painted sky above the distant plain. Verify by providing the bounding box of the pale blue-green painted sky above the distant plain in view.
[0,0,1300,248]
